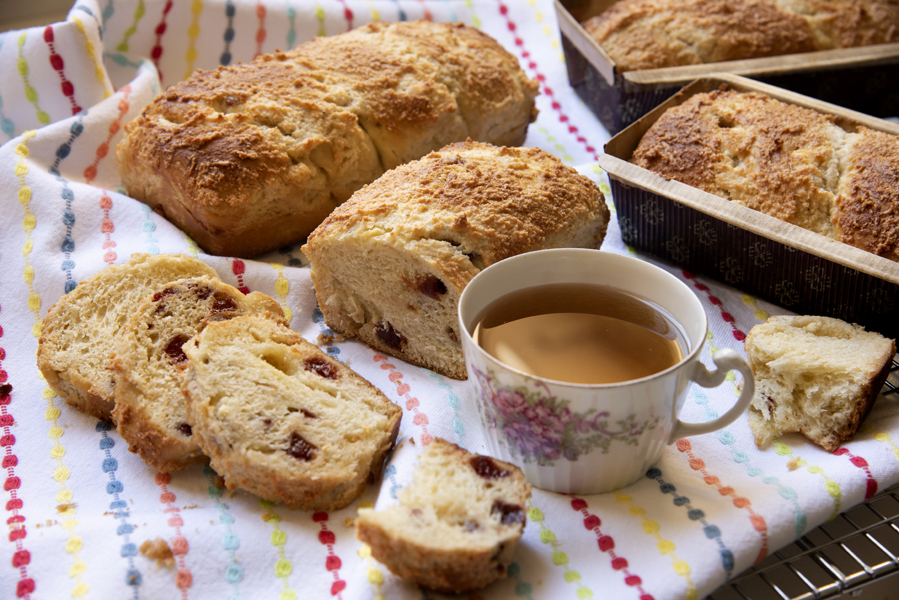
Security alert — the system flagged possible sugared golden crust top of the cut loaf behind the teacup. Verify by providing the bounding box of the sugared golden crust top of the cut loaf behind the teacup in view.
[308,141,608,268]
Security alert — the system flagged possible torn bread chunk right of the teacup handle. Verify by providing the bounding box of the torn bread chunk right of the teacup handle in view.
[746,316,896,452]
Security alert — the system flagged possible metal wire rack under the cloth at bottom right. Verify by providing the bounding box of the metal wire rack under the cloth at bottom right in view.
[709,360,899,600]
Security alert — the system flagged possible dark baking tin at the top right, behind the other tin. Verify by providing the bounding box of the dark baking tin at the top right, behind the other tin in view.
[556,0,899,135]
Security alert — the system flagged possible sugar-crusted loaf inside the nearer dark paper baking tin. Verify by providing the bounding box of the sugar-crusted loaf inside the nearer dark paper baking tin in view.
[631,90,899,260]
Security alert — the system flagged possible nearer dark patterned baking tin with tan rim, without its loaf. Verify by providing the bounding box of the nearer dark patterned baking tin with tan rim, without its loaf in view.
[599,74,899,338]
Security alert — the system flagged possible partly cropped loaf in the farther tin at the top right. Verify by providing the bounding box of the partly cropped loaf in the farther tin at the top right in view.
[583,0,899,72]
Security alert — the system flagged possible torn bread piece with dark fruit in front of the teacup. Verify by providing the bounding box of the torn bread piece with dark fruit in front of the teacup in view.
[356,438,531,593]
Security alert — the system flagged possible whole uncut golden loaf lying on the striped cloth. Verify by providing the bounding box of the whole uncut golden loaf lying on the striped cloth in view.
[116,21,538,257]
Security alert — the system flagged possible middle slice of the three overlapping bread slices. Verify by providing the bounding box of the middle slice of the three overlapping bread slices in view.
[110,277,287,473]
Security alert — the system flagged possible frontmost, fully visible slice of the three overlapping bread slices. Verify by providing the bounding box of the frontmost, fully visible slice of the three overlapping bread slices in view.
[183,315,402,510]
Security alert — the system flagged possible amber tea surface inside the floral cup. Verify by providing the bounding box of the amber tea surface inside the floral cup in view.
[473,284,687,384]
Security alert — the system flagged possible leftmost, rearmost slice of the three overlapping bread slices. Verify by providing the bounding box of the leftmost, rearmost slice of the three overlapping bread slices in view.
[37,254,218,421]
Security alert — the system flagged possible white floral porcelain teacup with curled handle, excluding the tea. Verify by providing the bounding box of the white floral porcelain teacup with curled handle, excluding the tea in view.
[459,249,754,494]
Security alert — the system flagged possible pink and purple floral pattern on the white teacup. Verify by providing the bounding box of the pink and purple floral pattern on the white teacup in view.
[475,369,659,466]
